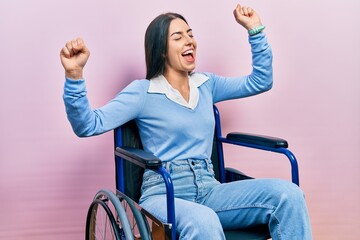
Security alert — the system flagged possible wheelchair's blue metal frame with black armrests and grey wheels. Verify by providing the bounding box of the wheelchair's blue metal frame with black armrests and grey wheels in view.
[86,105,299,239]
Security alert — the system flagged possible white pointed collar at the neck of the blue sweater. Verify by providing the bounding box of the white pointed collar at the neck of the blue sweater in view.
[148,73,209,110]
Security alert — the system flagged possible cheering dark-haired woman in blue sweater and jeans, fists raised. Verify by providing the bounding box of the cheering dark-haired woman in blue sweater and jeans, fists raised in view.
[60,5,312,240]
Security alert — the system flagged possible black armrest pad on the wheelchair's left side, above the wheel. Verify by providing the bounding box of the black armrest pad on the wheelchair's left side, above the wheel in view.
[115,147,162,169]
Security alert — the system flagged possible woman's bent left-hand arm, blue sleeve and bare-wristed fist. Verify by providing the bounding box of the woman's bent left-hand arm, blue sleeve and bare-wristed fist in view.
[60,39,145,137]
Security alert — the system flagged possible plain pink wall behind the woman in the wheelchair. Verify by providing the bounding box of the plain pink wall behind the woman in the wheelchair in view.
[0,0,360,240]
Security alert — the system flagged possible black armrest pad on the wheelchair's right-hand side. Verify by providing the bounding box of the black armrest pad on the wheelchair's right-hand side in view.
[226,132,288,148]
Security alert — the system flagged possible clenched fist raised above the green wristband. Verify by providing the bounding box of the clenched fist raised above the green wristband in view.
[234,4,262,30]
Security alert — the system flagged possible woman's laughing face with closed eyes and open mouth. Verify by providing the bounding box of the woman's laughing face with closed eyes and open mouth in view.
[165,18,197,77]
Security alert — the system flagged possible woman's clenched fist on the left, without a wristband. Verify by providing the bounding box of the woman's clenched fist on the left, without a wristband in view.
[60,38,90,80]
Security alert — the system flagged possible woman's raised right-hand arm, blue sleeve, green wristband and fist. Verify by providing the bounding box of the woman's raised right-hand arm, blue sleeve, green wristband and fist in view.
[209,4,273,103]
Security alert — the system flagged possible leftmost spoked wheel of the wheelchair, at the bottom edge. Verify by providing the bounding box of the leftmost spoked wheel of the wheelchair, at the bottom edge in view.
[86,190,134,240]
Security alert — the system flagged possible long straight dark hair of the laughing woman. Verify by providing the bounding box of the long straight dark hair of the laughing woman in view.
[145,12,187,80]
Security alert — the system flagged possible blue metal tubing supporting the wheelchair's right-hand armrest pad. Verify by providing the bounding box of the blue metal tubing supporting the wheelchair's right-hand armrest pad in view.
[214,105,300,186]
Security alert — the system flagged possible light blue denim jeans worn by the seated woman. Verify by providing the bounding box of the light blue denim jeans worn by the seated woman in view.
[140,159,312,240]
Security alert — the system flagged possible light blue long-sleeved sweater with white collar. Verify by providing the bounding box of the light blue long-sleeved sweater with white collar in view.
[64,33,272,161]
